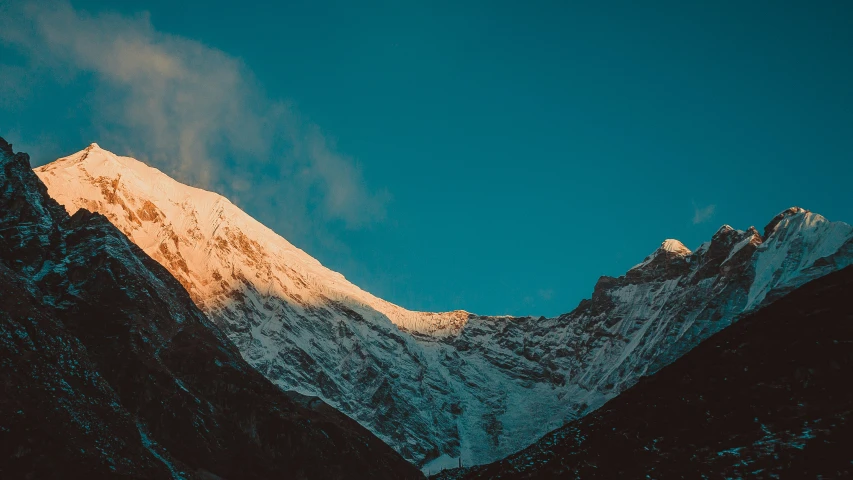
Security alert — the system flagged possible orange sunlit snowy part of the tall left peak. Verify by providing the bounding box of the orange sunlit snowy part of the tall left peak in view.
[36,143,470,336]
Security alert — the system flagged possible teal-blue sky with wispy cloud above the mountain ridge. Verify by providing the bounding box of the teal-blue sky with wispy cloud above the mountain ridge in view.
[0,0,853,315]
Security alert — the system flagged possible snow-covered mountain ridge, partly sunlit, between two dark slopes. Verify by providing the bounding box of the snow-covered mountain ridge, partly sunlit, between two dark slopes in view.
[36,144,853,472]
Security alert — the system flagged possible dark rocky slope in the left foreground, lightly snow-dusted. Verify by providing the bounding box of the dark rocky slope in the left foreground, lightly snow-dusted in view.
[0,139,422,479]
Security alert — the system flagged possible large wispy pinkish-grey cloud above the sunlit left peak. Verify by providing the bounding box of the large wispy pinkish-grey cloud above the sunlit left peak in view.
[0,1,388,240]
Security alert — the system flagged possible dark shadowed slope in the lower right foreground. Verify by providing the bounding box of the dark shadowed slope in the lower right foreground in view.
[435,267,853,480]
